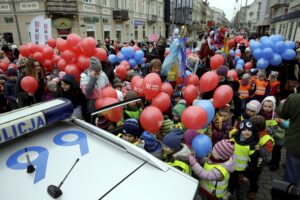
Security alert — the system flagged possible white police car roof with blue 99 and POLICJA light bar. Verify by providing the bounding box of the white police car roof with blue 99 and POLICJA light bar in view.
[0,99,198,200]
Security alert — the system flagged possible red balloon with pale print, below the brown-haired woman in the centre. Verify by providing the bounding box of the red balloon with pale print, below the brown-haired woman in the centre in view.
[144,73,161,100]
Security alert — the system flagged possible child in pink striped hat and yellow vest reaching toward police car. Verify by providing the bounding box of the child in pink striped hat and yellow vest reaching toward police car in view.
[188,139,235,199]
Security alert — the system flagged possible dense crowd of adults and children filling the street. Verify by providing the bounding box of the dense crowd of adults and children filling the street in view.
[0,33,300,199]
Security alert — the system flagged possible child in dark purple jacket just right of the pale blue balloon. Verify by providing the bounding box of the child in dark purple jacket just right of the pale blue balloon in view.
[212,104,232,145]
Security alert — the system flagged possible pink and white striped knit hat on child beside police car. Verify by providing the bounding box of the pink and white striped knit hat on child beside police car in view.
[213,139,234,160]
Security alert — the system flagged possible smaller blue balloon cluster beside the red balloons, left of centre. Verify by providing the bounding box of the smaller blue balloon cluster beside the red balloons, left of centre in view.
[108,45,146,68]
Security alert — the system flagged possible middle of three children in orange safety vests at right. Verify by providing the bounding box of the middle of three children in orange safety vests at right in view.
[252,71,268,102]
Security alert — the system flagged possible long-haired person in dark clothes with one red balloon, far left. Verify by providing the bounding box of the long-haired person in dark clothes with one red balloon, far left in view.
[16,58,45,108]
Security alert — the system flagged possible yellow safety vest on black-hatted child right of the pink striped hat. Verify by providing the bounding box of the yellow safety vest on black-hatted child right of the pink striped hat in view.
[234,142,255,171]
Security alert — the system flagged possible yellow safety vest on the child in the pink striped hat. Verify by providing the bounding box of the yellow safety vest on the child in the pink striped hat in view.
[200,162,230,198]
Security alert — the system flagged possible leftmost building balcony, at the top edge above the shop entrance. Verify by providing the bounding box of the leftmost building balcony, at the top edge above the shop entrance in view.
[46,0,78,16]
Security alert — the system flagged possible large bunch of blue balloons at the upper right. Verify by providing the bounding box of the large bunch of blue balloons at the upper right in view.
[250,35,296,69]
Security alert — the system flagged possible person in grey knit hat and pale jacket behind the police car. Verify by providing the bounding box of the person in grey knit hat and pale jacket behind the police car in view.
[80,57,110,112]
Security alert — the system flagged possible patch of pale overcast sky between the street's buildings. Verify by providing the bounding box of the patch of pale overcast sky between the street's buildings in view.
[208,0,254,21]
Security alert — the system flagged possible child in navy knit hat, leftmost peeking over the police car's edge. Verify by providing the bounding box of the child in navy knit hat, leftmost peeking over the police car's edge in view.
[118,118,141,144]
